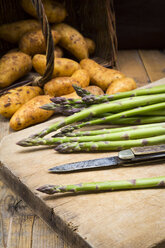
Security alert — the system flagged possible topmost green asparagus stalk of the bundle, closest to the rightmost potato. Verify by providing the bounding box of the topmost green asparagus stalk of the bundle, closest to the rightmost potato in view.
[82,85,165,104]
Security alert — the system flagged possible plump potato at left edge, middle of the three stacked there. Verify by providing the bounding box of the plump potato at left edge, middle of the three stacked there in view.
[0,51,32,88]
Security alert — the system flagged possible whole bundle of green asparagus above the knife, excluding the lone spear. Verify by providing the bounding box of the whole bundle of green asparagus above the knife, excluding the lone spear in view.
[17,85,165,153]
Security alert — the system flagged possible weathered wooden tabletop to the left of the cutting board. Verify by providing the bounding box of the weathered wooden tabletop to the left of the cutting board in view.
[0,116,71,248]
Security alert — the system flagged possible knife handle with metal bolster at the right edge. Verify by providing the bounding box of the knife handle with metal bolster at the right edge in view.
[118,145,165,166]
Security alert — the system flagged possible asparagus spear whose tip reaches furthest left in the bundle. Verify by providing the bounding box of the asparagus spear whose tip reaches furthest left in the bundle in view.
[18,125,165,147]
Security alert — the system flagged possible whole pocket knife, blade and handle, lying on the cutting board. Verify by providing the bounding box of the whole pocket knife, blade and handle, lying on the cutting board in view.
[49,145,165,173]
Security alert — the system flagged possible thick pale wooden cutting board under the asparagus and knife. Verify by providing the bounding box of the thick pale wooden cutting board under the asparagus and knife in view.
[0,80,165,248]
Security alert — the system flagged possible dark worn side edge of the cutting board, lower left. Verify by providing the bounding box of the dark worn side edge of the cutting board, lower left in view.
[0,78,165,248]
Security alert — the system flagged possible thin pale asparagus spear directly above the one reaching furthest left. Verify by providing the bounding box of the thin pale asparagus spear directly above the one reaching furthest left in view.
[61,122,165,137]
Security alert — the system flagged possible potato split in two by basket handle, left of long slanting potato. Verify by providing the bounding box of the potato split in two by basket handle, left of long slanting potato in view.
[19,29,61,55]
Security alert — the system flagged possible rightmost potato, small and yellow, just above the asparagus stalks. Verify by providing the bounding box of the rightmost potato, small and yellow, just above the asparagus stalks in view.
[106,77,137,95]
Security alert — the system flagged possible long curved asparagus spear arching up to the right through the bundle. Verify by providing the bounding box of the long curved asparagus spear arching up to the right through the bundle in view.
[27,94,165,138]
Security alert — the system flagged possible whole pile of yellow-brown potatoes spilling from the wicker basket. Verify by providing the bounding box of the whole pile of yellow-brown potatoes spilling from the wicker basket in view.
[0,0,136,131]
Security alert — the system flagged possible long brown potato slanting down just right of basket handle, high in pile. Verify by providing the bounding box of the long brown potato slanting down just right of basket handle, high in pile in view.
[52,23,88,60]
